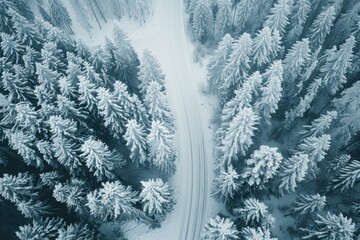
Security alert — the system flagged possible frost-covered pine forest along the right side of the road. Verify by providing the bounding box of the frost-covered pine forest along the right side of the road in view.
[197,0,360,239]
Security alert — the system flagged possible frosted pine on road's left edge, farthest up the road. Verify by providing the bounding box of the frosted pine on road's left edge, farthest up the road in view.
[138,49,165,96]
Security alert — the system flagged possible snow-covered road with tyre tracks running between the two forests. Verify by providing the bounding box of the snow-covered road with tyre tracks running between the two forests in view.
[70,0,221,240]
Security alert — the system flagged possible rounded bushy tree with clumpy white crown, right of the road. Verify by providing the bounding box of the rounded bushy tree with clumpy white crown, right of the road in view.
[241,145,283,188]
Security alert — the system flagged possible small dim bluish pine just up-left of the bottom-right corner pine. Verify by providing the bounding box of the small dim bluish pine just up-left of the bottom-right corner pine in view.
[292,194,326,216]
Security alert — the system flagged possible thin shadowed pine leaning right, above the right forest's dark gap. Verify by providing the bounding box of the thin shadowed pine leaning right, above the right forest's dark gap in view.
[285,78,323,127]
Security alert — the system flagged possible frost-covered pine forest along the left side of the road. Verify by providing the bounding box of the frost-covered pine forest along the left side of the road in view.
[0,4,176,239]
